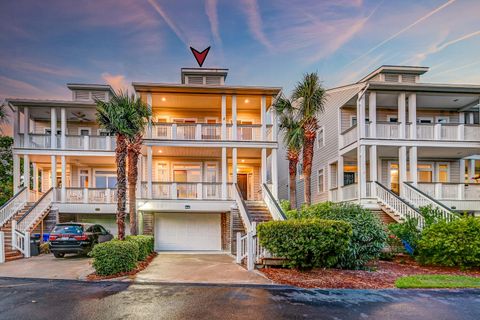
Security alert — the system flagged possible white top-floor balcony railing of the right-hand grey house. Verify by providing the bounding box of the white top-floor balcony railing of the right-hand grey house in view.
[340,121,480,148]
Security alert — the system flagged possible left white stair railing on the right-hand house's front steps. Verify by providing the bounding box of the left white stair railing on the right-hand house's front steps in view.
[375,182,425,228]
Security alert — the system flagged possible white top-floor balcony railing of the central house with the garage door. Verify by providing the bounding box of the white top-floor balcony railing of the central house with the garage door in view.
[146,122,274,141]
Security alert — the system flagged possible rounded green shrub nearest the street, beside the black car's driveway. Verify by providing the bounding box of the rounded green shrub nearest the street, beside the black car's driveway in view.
[89,240,138,276]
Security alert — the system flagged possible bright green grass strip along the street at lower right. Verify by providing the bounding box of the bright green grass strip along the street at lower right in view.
[395,274,480,289]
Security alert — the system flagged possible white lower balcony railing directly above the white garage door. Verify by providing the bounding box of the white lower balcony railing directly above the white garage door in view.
[140,182,232,200]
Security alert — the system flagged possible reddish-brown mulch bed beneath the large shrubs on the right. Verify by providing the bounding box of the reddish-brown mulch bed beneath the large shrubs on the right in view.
[260,257,480,289]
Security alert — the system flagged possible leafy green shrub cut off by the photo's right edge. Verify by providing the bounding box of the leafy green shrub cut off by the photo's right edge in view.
[418,217,480,268]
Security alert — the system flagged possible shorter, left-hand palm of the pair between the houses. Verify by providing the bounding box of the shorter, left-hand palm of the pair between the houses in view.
[275,97,303,208]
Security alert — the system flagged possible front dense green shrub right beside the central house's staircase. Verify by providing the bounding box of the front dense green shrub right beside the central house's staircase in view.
[257,219,352,269]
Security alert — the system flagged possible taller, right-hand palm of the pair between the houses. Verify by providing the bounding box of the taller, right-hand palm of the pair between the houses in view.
[292,72,326,205]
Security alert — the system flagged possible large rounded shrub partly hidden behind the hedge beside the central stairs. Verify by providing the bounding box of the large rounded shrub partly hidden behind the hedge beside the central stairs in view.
[297,202,387,269]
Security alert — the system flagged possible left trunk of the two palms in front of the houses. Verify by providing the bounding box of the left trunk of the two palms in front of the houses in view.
[115,134,126,240]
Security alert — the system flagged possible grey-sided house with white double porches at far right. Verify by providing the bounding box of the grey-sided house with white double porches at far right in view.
[279,66,480,221]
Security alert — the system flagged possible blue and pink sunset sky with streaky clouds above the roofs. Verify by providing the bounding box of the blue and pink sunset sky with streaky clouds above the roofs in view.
[0,0,480,102]
